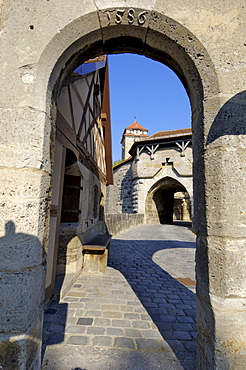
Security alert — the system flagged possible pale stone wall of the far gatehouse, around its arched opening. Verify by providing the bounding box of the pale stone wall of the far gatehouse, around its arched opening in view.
[106,144,193,223]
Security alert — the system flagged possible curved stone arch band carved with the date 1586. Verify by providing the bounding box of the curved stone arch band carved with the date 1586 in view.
[35,15,218,368]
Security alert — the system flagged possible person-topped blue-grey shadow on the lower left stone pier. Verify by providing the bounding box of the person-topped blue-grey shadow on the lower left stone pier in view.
[0,220,46,370]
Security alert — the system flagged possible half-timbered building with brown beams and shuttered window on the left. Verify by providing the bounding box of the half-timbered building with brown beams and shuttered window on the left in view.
[46,56,112,298]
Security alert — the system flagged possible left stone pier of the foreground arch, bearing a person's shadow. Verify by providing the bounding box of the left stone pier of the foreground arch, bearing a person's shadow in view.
[0,108,51,370]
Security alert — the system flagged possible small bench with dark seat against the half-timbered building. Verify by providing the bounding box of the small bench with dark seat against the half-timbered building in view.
[83,234,112,273]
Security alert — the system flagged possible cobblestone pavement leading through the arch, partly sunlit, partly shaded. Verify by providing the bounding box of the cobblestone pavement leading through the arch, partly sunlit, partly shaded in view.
[42,225,197,370]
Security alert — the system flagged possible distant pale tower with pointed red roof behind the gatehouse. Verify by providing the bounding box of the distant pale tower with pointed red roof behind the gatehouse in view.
[121,120,149,159]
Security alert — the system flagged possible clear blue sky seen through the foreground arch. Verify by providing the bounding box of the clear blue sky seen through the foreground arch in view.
[109,54,191,161]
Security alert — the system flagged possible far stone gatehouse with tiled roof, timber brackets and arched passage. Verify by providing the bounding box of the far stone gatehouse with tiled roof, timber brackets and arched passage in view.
[106,126,193,223]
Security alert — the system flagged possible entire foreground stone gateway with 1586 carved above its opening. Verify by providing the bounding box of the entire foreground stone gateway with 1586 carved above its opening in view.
[0,0,246,369]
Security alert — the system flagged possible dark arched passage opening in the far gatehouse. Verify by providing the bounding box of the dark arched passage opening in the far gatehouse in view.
[145,177,191,224]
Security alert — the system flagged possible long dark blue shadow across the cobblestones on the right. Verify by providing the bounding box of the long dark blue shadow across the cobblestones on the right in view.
[108,236,197,370]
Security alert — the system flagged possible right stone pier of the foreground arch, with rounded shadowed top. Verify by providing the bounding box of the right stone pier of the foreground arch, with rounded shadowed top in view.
[195,93,246,370]
